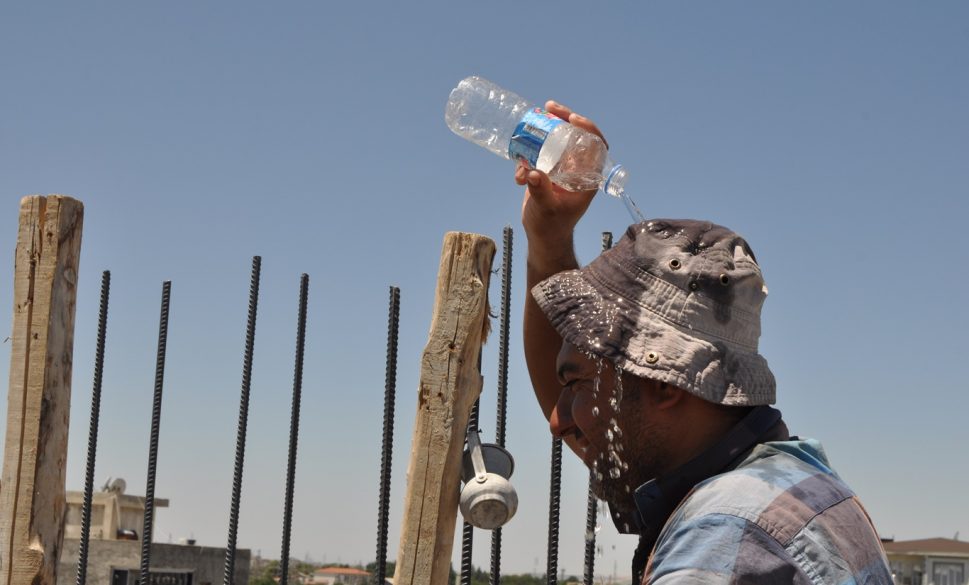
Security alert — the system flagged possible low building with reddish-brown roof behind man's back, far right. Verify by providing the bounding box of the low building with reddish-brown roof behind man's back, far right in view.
[883,538,969,585]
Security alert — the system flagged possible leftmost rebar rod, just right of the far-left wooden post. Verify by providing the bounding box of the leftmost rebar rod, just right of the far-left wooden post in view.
[76,270,111,585]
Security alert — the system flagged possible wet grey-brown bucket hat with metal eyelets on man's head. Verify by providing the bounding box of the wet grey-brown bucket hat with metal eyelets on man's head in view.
[532,219,775,406]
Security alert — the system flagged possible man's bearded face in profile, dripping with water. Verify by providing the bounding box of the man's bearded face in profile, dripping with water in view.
[549,343,669,508]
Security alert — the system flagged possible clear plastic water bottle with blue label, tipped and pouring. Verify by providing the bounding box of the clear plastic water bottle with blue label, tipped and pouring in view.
[444,76,643,221]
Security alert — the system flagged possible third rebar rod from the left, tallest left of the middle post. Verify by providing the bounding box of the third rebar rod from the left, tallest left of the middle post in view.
[222,256,262,585]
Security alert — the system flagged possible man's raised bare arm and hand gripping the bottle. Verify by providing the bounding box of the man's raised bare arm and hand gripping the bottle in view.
[515,101,605,420]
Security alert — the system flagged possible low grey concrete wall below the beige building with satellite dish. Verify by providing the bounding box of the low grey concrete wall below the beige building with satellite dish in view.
[57,538,250,585]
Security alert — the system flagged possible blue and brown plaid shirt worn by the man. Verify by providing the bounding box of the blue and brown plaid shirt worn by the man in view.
[643,438,892,585]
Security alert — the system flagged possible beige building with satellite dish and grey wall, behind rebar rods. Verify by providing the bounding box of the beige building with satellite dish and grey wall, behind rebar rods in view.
[57,479,250,585]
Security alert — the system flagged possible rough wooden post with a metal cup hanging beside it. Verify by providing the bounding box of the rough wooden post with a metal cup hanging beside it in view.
[394,232,495,585]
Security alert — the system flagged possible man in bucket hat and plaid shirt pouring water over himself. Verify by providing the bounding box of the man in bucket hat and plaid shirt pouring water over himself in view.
[515,102,892,584]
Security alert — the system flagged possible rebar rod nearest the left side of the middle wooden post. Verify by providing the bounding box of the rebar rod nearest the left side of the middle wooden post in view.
[374,286,400,585]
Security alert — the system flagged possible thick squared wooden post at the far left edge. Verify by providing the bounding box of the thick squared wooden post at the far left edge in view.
[0,195,84,585]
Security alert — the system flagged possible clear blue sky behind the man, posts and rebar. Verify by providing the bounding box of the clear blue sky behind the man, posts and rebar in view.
[0,1,969,574]
